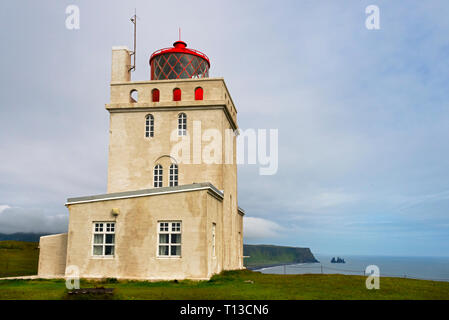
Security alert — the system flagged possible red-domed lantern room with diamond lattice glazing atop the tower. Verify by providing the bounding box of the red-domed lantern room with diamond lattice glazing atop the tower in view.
[150,40,210,80]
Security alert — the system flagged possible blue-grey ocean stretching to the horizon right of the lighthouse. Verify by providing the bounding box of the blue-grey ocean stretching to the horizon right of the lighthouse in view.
[257,254,449,281]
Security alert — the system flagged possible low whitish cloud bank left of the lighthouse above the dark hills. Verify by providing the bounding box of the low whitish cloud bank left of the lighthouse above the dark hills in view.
[0,205,68,233]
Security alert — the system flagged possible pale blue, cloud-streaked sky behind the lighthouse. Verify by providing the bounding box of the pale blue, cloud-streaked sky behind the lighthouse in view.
[0,0,449,256]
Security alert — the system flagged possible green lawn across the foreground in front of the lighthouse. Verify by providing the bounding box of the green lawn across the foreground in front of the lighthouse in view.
[0,270,449,300]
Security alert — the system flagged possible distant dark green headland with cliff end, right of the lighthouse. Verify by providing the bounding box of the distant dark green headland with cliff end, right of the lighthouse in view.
[243,244,318,269]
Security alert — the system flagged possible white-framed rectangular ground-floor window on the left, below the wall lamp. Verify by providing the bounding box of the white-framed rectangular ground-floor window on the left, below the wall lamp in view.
[92,222,115,256]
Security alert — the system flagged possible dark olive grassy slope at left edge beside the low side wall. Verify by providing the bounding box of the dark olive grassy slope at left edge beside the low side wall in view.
[0,241,39,278]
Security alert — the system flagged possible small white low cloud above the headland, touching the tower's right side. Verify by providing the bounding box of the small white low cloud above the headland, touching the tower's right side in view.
[243,217,284,240]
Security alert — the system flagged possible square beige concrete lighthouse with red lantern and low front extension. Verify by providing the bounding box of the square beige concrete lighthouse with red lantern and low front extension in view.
[39,40,244,280]
